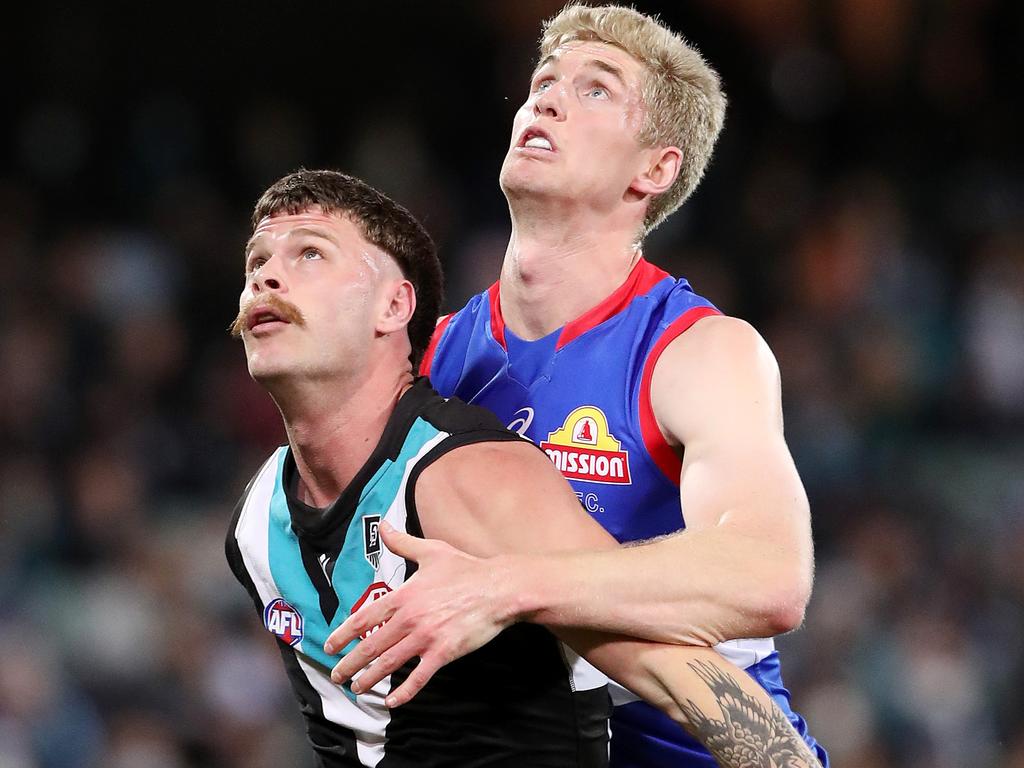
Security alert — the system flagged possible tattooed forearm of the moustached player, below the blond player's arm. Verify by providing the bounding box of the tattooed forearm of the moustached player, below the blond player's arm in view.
[557,630,820,768]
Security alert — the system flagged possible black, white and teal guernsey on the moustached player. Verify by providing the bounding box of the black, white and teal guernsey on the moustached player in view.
[226,379,610,768]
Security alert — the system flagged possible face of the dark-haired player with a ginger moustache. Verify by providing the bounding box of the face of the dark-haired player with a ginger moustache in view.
[231,207,401,384]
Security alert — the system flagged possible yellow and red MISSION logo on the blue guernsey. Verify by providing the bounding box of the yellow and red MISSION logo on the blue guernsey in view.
[541,406,630,485]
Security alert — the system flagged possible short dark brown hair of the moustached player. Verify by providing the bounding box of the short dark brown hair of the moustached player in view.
[252,168,441,371]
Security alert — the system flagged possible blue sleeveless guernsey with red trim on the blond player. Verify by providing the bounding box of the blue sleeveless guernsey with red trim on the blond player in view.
[420,259,827,768]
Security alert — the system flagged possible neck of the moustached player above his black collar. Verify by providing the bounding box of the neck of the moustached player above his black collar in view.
[271,367,413,507]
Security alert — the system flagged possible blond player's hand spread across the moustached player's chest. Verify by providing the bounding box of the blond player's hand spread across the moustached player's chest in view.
[324,522,515,708]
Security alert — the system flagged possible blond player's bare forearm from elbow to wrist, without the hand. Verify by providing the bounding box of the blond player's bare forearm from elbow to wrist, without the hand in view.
[496,525,810,645]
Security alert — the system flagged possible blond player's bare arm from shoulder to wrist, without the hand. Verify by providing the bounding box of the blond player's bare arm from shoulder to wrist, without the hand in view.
[512,317,813,645]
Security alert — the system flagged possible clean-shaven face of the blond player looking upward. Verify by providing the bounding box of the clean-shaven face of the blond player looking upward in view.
[501,42,647,211]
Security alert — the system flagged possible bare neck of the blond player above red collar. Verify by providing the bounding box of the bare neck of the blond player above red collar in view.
[501,201,641,340]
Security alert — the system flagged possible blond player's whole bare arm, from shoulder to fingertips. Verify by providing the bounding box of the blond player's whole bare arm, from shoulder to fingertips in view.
[332,317,812,696]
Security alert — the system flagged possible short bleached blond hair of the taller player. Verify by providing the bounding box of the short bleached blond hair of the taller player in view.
[540,3,725,234]
